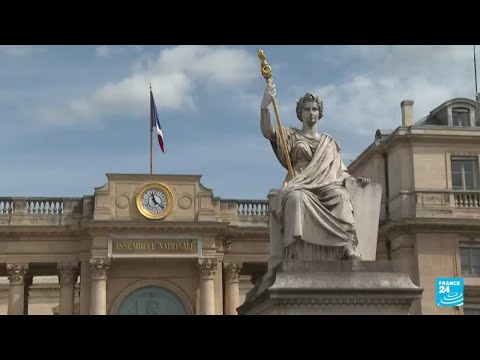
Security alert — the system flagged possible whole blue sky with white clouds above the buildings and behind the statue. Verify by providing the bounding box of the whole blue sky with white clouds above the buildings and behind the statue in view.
[0,45,479,199]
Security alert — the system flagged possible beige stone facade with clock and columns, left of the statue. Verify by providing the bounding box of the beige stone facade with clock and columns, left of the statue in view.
[0,174,269,314]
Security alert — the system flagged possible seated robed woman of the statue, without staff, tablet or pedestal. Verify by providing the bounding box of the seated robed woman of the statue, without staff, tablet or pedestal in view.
[260,78,369,272]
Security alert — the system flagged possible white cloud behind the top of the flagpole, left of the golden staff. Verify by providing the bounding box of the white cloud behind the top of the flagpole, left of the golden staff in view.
[40,46,258,125]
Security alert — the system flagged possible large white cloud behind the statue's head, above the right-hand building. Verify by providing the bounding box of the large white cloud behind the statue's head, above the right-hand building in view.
[280,45,475,137]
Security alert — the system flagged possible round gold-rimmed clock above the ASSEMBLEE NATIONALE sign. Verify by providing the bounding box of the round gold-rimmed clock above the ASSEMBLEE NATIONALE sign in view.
[137,183,173,219]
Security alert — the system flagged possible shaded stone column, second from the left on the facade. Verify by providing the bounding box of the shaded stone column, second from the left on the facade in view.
[57,263,78,315]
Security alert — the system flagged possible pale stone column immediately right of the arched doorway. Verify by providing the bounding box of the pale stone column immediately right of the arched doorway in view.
[198,259,217,315]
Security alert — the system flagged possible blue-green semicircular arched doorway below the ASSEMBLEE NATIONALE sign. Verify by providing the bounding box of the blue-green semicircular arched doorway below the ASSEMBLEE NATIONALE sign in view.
[116,286,188,315]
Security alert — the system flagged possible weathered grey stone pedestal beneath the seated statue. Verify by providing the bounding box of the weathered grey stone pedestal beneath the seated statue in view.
[237,260,423,315]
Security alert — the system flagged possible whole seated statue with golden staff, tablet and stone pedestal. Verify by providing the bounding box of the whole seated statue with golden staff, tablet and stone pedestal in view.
[237,49,410,315]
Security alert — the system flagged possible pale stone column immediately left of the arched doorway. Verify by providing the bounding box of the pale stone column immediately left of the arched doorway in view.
[90,258,110,315]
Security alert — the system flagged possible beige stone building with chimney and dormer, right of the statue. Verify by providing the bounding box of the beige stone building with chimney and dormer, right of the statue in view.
[349,98,480,315]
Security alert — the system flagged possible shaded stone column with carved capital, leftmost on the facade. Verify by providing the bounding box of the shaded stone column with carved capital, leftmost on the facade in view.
[7,263,28,315]
